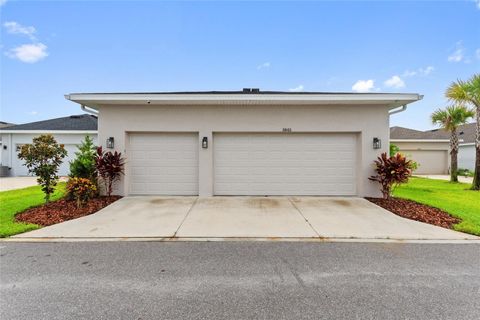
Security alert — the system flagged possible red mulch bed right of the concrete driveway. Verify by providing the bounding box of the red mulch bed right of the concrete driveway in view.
[365,198,461,229]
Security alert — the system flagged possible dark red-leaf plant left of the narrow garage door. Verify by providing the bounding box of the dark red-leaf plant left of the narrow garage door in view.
[95,147,125,196]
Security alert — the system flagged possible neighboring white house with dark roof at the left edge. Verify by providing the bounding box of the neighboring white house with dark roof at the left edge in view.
[0,114,97,176]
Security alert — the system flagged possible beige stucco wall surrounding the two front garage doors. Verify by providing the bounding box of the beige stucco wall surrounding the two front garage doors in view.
[98,105,389,196]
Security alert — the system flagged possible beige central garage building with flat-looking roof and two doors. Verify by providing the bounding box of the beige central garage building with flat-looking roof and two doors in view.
[65,89,422,196]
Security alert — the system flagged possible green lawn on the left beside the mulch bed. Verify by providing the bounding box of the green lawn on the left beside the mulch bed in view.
[0,182,65,238]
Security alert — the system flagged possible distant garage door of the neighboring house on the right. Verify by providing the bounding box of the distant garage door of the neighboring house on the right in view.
[403,150,448,174]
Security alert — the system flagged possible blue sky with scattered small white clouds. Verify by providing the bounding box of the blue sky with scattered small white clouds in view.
[0,0,480,129]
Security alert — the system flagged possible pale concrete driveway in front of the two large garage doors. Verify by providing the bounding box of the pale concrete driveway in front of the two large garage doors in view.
[15,197,478,240]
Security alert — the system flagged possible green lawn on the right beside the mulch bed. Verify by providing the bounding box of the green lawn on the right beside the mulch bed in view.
[394,178,480,236]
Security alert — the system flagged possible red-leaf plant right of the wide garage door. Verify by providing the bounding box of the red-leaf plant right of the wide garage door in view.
[368,152,414,199]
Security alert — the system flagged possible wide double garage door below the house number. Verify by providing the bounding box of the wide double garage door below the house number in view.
[213,133,357,195]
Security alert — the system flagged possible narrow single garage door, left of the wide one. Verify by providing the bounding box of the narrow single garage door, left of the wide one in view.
[126,133,199,195]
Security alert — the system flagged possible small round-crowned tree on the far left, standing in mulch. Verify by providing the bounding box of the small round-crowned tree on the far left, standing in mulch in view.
[18,134,67,203]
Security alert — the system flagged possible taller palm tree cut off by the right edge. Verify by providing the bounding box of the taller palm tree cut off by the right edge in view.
[445,73,480,190]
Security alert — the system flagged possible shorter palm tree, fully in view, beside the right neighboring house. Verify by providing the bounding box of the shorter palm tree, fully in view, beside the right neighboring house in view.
[431,105,475,182]
